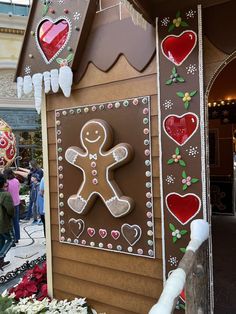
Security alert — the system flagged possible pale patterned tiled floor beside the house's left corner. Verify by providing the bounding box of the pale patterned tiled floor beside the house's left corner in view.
[0,220,45,284]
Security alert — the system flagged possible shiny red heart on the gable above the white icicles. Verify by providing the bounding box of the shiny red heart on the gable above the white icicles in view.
[36,17,70,63]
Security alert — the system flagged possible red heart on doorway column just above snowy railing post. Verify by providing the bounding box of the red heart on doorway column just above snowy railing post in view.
[166,193,201,225]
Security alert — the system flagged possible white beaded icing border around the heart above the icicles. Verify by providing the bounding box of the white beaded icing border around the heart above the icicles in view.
[35,16,72,64]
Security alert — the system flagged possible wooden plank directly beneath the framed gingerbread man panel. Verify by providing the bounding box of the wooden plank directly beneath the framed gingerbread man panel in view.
[52,236,163,279]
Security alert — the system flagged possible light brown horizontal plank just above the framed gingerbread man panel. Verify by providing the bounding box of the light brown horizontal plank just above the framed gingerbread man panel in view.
[47,75,156,111]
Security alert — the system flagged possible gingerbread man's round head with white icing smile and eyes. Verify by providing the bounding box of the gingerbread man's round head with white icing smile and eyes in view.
[81,120,111,150]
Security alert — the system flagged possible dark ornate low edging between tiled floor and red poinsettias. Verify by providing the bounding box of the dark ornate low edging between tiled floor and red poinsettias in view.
[0,254,46,284]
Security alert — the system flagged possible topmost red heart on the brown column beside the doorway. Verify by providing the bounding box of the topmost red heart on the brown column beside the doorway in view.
[161,31,197,66]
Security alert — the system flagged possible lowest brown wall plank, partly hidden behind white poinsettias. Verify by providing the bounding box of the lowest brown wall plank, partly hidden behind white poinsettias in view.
[54,287,136,314]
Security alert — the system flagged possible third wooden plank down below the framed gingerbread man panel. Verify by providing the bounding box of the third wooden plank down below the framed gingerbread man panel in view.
[53,274,155,314]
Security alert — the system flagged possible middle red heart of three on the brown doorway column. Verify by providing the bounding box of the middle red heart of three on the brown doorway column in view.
[163,113,199,146]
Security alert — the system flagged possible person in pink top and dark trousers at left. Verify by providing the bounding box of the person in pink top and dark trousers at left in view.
[4,168,20,246]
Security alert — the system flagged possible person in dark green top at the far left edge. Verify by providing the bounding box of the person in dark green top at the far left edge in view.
[0,174,15,270]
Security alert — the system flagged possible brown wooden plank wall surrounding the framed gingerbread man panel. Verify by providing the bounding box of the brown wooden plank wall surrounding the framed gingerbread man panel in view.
[47,56,163,314]
